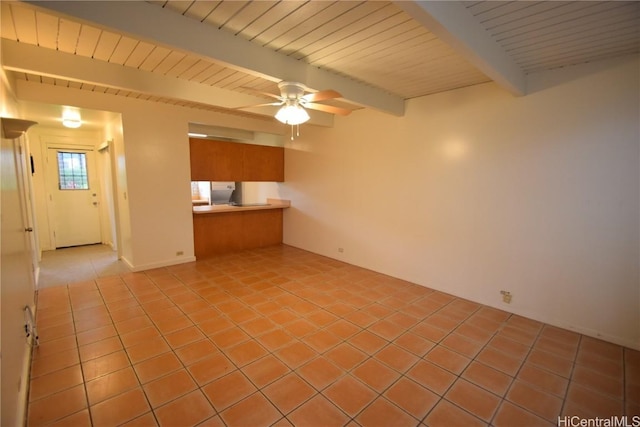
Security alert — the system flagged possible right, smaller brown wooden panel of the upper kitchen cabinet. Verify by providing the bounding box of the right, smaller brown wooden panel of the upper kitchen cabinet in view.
[242,144,284,182]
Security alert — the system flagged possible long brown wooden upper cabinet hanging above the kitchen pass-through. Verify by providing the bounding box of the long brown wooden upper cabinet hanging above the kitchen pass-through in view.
[189,138,284,182]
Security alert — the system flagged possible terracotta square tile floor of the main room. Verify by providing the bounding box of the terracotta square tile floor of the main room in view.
[28,246,640,427]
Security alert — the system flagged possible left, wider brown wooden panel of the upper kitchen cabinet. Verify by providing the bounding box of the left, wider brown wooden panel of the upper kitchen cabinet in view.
[189,138,244,181]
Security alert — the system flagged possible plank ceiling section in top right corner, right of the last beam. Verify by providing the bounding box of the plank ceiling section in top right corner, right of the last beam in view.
[464,1,640,73]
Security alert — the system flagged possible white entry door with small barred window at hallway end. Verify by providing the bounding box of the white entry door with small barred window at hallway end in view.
[47,147,101,248]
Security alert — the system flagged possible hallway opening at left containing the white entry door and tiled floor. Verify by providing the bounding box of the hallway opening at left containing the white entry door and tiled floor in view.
[30,129,124,288]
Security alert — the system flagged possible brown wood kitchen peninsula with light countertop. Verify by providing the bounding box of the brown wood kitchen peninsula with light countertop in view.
[193,199,291,259]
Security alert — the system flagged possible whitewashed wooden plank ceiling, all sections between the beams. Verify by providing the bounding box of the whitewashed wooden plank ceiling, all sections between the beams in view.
[0,0,640,120]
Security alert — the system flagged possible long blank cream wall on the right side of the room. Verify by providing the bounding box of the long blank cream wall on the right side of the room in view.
[282,58,640,348]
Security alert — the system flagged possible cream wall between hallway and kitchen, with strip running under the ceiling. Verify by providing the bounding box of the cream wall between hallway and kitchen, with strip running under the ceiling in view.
[17,80,283,270]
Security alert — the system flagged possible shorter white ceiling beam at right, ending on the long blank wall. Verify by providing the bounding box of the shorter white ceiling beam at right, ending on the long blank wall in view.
[395,0,526,96]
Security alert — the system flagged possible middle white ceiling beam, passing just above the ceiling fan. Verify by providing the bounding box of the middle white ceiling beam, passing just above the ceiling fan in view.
[25,0,404,116]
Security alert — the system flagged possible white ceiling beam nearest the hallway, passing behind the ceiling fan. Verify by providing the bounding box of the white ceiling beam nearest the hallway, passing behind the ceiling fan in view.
[1,39,333,126]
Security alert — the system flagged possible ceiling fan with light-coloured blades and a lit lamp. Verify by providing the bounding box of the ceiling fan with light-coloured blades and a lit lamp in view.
[237,81,351,139]
